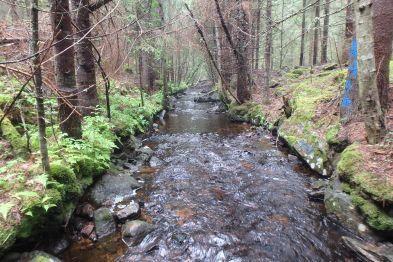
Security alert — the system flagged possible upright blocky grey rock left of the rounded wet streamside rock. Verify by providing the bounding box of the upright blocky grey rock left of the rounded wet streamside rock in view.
[94,207,116,239]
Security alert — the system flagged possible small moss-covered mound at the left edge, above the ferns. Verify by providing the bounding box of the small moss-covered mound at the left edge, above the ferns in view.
[0,110,27,154]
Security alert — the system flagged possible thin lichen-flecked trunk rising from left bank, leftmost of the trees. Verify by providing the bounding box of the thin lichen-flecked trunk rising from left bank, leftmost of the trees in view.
[31,0,50,172]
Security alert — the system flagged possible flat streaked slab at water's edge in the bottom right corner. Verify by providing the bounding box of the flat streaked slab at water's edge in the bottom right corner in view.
[342,237,393,262]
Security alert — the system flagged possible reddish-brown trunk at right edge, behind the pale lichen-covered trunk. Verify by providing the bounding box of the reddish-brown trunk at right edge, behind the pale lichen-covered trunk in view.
[373,0,393,112]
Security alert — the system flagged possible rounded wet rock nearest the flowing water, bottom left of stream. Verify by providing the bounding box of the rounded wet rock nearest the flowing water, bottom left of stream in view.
[121,220,155,245]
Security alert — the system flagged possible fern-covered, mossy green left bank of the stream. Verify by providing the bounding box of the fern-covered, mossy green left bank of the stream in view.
[0,79,185,256]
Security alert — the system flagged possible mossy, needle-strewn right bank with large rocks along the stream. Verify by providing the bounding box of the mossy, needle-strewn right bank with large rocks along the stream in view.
[229,67,393,240]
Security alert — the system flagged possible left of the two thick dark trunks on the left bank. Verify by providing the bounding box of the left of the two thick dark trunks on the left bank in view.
[50,0,82,138]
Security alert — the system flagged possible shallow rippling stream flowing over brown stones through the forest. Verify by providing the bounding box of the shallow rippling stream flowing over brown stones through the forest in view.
[62,85,346,262]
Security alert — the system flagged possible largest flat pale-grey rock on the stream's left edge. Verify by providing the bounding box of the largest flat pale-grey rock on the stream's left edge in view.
[88,174,141,206]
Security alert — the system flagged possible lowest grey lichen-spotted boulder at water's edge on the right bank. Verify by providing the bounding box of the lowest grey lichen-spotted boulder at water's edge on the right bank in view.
[324,177,371,237]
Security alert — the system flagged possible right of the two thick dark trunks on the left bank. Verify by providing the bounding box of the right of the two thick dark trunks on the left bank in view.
[71,0,98,115]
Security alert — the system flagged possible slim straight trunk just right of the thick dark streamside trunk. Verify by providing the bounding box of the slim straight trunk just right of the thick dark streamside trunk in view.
[265,0,273,87]
